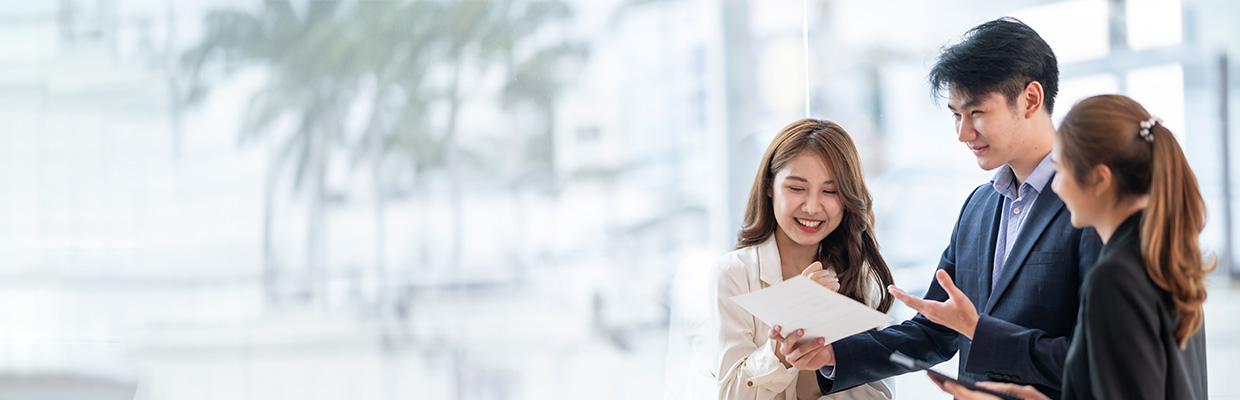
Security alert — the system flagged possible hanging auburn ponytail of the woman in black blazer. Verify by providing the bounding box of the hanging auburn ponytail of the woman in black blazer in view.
[1141,124,1218,348]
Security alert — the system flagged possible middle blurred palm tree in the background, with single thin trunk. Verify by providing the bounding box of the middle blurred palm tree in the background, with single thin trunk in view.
[350,1,448,303]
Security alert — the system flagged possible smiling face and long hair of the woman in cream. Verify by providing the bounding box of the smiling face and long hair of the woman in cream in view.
[737,119,893,312]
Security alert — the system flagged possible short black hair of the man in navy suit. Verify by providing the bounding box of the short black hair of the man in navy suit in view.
[930,17,1059,114]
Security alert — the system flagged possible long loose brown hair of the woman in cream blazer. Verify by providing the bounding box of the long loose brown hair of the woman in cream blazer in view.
[737,119,893,312]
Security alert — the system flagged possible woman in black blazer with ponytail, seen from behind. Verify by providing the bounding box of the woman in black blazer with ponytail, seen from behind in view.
[939,95,1215,399]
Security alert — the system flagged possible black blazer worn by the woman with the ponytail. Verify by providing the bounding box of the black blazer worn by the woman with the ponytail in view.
[1064,212,1207,400]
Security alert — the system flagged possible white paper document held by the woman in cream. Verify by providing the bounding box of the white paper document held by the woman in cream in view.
[732,276,893,343]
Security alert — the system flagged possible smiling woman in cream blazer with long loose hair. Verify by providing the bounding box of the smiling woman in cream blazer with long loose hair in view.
[711,119,892,399]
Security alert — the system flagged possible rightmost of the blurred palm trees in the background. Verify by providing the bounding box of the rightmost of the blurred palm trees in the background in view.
[444,0,588,271]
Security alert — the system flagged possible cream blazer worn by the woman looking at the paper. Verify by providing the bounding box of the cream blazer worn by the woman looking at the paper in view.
[709,235,893,400]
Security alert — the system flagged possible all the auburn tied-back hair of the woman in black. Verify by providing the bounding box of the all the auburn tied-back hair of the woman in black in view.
[1055,94,1218,347]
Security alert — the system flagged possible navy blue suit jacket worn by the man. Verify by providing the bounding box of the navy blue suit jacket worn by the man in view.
[818,182,1102,398]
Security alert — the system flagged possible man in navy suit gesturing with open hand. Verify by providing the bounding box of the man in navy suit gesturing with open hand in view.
[770,19,1101,398]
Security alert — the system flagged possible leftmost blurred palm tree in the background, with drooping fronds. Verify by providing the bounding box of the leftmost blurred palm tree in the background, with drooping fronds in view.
[182,0,365,300]
